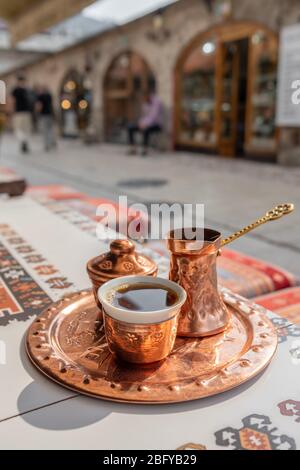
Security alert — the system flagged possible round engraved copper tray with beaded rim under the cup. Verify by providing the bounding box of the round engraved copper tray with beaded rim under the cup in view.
[26,291,277,404]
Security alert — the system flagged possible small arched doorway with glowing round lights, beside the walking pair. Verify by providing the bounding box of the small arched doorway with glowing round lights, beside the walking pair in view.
[60,70,92,137]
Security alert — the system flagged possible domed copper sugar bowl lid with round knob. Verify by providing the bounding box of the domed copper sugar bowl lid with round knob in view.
[87,239,157,282]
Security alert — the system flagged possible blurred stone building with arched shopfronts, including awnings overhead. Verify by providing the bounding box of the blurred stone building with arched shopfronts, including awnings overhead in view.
[0,0,300,160]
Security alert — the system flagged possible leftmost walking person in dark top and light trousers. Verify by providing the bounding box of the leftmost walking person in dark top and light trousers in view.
[11,76,32,153]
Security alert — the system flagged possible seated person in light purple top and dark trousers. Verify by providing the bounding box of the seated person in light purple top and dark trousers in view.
[128,93,163,155]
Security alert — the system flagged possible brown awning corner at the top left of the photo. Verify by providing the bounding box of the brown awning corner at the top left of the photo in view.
[0,0,94,45]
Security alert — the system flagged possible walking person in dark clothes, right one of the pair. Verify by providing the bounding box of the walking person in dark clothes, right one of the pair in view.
[36,87,56,152]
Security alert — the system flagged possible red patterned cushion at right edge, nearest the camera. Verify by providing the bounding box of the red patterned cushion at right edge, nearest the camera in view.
[255,287,300,325]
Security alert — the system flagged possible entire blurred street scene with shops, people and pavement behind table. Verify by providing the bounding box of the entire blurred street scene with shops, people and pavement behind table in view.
[0,0,300,273]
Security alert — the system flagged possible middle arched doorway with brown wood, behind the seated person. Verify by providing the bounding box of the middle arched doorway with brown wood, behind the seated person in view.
[104,51,155,143]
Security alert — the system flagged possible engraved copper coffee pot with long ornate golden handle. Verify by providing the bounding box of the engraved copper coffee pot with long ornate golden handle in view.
[167,204,294,337]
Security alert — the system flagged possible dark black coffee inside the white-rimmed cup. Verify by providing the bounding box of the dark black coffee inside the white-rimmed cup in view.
[111,283,178,312]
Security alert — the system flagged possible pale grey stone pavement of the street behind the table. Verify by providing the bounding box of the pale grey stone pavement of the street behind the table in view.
[0,135,300,276]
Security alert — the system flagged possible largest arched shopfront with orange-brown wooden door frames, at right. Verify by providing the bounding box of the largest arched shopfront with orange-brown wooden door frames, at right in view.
[174,22,278,156]
